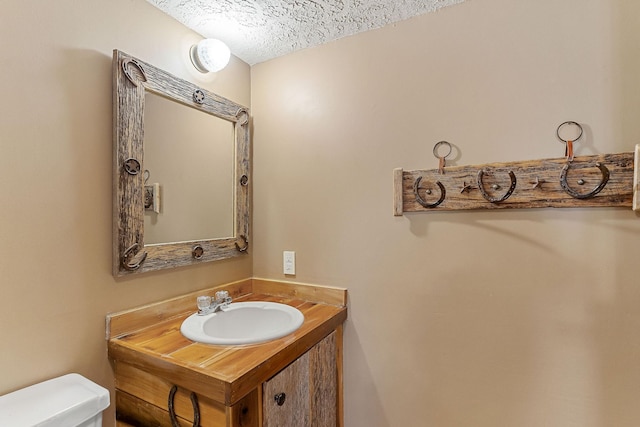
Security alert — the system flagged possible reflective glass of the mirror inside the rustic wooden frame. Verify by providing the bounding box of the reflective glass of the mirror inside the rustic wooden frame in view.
[144,93,234,245]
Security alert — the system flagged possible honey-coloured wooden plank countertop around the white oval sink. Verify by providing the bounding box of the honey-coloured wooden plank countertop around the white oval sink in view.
[107,280,347,406]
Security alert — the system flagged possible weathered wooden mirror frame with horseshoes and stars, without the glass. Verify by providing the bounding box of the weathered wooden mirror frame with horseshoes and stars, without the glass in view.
[113,50,250,276]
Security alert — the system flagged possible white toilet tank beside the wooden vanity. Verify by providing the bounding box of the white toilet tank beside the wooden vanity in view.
[0,374,109,427]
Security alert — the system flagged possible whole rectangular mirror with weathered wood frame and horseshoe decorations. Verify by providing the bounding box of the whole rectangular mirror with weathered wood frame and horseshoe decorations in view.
[113,50,250,276]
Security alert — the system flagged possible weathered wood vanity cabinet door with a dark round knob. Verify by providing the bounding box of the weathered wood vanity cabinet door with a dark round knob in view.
[263,332,338,427]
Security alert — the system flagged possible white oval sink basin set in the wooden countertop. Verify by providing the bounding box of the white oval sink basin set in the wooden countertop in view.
[180,302,304,345]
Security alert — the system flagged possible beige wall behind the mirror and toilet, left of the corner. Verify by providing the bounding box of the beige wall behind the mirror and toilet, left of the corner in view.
[0,0,252,425]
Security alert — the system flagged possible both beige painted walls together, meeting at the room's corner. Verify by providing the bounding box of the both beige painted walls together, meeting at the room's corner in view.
[0,0,640,427]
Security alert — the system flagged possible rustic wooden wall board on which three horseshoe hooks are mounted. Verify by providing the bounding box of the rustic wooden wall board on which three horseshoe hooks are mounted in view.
[394,153,634,215]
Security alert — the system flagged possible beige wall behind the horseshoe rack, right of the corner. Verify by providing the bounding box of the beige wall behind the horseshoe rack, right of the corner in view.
[251,0,640,427]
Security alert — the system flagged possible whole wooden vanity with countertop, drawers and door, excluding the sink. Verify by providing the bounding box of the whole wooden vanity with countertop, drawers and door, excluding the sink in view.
[107,279,347,427]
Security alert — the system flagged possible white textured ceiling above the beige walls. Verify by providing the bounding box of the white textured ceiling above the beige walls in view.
[147,0,464,65]
